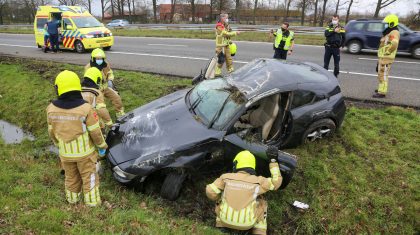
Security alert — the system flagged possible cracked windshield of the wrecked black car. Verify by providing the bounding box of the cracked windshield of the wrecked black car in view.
[188,79,245,129]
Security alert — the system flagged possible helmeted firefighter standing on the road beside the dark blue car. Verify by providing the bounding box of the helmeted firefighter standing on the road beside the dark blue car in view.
[373,14,400,98]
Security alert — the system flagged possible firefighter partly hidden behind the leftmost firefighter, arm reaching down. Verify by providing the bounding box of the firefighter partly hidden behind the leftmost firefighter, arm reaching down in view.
[82,67,113,131]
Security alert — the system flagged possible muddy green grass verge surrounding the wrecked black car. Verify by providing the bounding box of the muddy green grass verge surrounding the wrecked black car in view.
[0,58,420,234]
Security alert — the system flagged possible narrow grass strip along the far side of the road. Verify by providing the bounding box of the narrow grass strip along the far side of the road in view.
[0,28,325,45]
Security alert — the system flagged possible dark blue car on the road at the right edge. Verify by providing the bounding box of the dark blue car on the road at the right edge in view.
[345,19,420,59]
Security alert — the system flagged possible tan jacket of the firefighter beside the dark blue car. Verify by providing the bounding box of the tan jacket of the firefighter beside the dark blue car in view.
[378,27,400,64]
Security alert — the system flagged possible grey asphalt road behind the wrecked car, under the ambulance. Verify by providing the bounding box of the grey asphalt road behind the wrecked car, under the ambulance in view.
[0,34,420,107]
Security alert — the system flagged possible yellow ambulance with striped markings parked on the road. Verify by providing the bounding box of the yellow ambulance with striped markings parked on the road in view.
[34,6,114,53]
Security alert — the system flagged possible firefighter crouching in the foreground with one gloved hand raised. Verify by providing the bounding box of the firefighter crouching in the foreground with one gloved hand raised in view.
[206,147,283,234]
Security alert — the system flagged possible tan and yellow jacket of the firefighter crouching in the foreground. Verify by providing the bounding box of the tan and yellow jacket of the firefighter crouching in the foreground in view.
[206,163,283,230]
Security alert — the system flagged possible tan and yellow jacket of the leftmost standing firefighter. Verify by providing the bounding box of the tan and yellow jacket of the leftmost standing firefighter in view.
[47,102,108,161]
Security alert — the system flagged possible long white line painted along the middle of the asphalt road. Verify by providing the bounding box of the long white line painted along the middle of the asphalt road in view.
[0,44,420,81]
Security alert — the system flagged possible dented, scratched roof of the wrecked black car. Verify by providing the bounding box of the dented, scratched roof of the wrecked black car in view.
[227,59,330,98]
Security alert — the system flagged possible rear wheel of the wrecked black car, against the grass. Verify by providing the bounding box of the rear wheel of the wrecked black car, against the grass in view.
[302,118,336,143]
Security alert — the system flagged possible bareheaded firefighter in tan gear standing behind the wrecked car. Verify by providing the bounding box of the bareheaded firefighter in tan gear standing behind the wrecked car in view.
[215,14,240,77]
